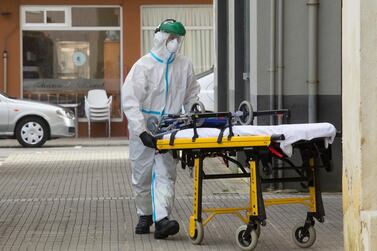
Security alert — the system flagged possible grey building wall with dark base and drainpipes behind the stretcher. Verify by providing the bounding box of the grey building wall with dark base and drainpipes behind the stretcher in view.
[214,0,342,191]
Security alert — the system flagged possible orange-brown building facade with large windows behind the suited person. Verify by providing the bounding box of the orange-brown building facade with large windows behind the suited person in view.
[0,0,214,137]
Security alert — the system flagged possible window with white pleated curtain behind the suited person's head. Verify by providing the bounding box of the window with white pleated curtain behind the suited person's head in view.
[141,5,214,73]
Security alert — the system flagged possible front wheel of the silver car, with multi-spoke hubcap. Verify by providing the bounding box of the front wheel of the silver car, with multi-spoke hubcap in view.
[16,117,48,147]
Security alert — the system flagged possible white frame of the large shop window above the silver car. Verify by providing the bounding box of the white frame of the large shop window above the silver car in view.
[19,5,124,122]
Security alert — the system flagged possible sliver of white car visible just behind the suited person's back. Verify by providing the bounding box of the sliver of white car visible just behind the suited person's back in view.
[196,68,215,112]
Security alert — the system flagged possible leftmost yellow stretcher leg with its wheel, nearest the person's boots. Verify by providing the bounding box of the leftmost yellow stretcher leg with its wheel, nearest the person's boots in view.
[189,156,204,245]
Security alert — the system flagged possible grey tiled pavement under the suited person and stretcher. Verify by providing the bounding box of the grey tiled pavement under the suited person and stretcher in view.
[0,146,343,251]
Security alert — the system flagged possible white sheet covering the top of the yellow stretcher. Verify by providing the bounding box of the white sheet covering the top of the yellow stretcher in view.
[164,123,336,157]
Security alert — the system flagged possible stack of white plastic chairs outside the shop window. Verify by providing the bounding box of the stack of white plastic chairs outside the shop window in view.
[85,89,113,138]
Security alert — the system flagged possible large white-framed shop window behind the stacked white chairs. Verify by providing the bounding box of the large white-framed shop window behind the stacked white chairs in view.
[22,6,122,119]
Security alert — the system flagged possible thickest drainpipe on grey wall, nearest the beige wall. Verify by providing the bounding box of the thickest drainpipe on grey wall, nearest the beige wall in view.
[306,0,319,123]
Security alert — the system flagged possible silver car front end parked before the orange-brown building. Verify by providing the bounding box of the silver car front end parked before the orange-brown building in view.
[0,92,76,147]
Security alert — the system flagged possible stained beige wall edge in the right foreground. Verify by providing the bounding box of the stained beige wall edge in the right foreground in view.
[343,0,377,248]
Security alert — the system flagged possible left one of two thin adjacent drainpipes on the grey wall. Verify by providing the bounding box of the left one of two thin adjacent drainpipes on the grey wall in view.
[269,0,276,125]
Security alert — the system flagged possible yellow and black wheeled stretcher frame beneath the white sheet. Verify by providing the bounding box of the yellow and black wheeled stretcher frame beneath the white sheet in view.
[157,132,331,250]
